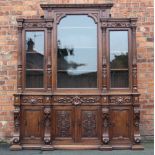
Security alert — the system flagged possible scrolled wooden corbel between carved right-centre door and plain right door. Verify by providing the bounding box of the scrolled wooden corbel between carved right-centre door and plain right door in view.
[102,108,110,144]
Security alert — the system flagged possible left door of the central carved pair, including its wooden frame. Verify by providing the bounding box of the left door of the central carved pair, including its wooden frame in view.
[52,106,75,141]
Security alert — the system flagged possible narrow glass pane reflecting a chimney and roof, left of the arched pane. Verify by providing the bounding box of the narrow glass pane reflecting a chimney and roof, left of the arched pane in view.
[26,31,44,88]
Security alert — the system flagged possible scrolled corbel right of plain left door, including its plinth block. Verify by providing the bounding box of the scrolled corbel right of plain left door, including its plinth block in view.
[42,107,53,150]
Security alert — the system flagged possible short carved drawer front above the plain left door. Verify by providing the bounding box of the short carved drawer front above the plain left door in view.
[22,96,43,104]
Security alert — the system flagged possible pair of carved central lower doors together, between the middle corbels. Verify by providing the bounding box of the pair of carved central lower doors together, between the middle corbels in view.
[52,106,101,144]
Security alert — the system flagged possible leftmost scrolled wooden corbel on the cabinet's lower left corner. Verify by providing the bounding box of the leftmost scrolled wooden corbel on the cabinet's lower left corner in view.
[12,106,20,145]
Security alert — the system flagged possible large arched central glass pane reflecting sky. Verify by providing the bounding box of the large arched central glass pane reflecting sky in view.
[57,15,97,88]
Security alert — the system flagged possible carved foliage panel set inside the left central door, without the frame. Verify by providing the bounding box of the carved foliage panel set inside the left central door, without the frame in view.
[57,111,71,137]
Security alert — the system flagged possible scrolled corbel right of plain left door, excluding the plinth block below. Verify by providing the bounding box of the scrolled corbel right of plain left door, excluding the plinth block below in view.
[44,107,51,145]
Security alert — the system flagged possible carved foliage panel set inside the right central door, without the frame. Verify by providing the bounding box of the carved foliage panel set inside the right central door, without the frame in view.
[82,111,97,137]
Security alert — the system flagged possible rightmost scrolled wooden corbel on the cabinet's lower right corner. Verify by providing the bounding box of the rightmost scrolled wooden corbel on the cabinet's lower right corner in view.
[134,107,141,144]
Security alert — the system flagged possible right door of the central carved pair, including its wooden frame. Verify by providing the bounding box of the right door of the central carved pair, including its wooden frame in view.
[76,106,101,142]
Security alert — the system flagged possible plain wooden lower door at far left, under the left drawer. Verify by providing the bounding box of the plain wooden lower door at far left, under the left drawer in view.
[21,106,43,143]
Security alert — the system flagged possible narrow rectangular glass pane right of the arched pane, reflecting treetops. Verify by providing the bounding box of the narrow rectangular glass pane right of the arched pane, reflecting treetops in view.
[110,31,129,88]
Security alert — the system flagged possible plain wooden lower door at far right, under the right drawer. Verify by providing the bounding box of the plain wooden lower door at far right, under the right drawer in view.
[110,107,132,140]
